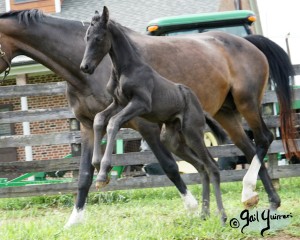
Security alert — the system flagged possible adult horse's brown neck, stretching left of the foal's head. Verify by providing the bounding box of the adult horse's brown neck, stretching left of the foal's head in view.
[0,16,92,89]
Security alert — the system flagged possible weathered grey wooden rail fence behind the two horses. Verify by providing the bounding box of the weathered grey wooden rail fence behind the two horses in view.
[0,65,300,198]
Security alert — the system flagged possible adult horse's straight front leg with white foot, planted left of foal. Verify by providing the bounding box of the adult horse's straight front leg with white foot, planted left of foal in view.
[64,125,95,228]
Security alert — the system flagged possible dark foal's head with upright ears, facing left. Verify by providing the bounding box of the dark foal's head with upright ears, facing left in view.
[80,7,111,74]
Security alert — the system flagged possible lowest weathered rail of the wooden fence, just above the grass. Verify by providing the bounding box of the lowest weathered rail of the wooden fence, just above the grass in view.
[0,164,300,198]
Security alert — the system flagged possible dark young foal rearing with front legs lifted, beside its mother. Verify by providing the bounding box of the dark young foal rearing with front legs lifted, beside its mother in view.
[81,7,226,223]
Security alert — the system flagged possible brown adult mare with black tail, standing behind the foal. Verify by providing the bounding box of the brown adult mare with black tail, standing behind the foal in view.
[0,10,293,226]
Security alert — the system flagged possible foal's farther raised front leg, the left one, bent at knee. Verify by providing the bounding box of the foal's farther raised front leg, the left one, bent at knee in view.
[92,100,119,172]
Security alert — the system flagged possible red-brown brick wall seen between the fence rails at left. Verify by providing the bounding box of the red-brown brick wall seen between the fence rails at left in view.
[0,74,71,161]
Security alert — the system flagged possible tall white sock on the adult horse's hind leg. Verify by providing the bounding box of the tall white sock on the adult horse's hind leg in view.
[242,155,261,202]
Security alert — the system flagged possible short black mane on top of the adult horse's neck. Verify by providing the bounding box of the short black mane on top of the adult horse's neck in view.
[0,9,44,25]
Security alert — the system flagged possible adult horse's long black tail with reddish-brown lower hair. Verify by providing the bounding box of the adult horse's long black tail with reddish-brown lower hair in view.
[245,35,300,157]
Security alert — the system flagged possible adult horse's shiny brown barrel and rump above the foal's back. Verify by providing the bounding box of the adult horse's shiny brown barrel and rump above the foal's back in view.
[132,32,268,115]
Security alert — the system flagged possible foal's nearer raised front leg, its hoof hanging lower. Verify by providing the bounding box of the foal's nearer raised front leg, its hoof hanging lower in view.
[96,98,149,188]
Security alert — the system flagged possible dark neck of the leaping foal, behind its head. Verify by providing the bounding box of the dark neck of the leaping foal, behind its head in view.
[108,21,140,74]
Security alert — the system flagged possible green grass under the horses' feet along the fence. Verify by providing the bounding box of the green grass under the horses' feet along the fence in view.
[0,178,300,240]
